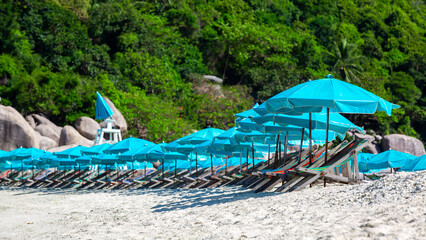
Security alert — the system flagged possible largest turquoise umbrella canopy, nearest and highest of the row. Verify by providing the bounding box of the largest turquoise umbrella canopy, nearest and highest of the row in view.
[266,75,399,116]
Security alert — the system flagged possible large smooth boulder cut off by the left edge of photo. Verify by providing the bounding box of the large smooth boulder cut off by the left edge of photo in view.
[0,105,40,151]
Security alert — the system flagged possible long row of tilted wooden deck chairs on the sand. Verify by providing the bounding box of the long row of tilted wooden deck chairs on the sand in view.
[0,140,367,192]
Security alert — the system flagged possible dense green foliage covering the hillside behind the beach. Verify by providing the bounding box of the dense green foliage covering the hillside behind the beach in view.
[0,0,426,142]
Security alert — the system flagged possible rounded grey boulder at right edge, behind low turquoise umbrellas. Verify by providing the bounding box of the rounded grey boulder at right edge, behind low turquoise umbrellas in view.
[382,134,426,157]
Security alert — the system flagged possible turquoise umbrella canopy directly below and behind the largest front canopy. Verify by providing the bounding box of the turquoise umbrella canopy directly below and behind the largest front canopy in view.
[253,110,363,137]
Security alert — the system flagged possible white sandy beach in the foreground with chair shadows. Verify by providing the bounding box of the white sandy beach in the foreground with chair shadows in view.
[0,172,426,239]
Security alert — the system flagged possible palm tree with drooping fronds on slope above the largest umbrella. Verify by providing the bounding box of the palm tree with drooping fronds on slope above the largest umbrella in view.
[331,39,363,82]
